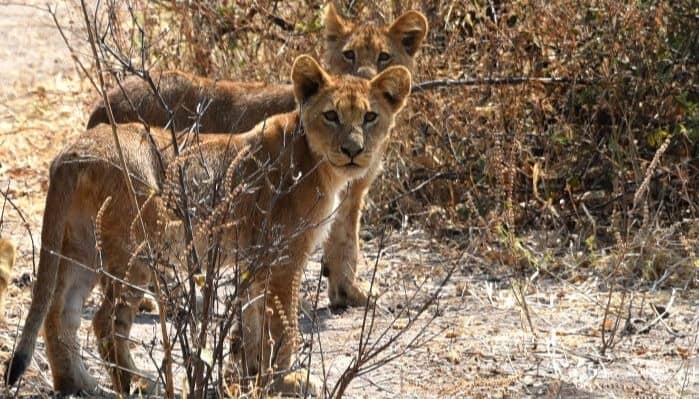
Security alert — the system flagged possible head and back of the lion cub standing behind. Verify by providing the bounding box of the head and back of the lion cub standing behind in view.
[87,3,427,133]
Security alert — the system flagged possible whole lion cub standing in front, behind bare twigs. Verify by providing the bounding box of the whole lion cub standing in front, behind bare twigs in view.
[5,56,411,394]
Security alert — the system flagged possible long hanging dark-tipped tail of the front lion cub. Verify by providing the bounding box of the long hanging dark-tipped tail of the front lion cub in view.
[5,156,79,385]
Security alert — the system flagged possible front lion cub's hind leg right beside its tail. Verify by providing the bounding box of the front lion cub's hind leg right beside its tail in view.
[44,222,97,394]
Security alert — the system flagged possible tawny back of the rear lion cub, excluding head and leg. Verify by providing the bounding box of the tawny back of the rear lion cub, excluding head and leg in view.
[87,71,295,133]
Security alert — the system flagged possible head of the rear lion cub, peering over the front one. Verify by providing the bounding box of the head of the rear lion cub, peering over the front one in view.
[325,3,427,78]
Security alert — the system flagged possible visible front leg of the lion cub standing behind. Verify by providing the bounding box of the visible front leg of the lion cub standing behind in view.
[323,173,376,307]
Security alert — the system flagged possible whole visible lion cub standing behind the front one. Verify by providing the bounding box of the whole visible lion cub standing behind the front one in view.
[88,3,428,307]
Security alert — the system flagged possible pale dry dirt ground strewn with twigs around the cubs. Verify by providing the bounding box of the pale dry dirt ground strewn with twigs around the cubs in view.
[0,2,699,398]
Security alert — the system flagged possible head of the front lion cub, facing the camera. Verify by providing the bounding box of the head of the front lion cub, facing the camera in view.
[291,56,411,179]
